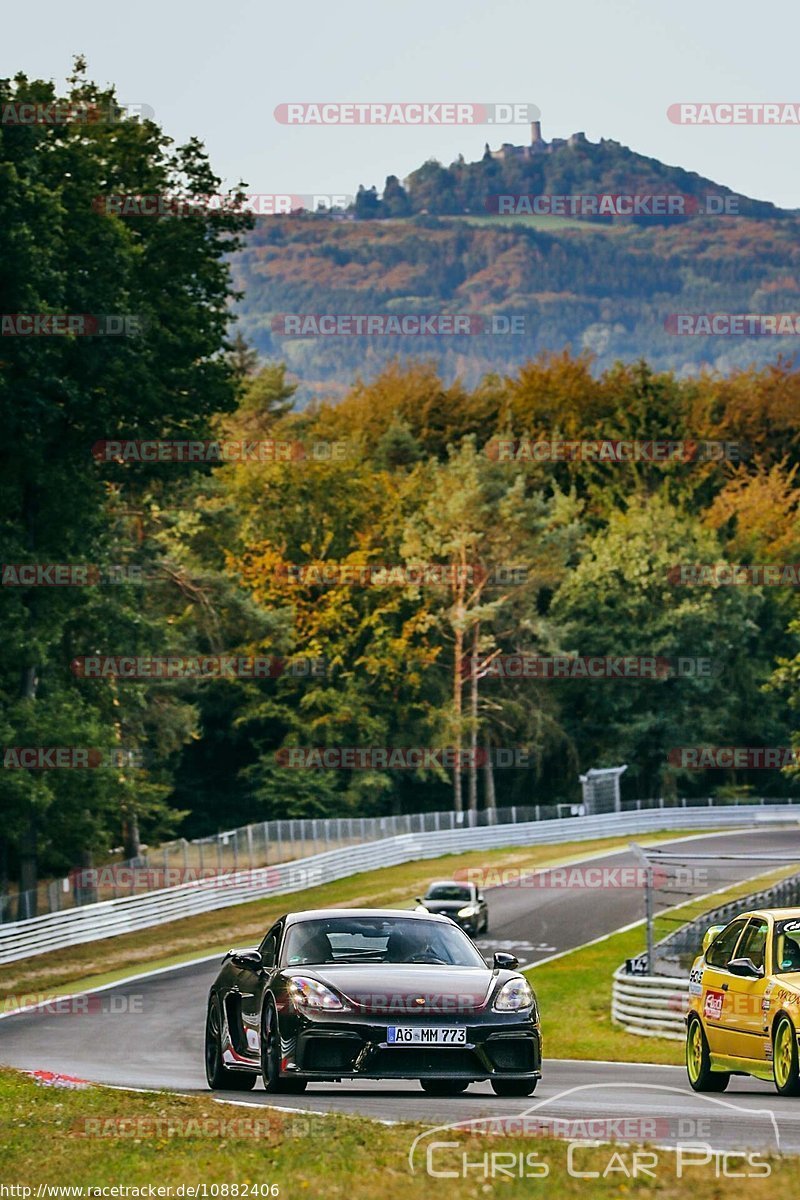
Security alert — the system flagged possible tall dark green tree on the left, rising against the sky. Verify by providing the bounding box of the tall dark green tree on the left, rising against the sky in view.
[0,60,251,907]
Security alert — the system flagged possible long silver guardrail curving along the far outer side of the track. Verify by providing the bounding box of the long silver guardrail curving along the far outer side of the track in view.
[0,805,800,964]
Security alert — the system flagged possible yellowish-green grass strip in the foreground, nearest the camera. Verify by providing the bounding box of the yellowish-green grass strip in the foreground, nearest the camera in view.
[0,1070,800,1200]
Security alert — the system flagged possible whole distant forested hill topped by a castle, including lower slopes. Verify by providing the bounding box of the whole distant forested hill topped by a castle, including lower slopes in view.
[235,130,800,398]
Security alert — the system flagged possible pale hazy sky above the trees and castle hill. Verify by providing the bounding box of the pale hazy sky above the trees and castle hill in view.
[6,0,800,208]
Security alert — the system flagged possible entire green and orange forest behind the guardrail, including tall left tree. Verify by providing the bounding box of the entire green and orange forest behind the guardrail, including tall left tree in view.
[0,64,800,902]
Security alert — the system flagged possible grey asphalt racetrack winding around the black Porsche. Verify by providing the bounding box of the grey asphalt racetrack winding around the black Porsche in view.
[0,824,800,1152]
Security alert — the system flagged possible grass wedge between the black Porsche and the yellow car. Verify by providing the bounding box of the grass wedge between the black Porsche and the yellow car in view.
[525,866,796,1066]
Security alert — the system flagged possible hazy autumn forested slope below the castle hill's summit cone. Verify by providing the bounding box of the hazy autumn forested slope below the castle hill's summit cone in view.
[234,206,800,393]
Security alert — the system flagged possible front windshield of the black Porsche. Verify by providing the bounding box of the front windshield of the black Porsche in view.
[281,917,486,967]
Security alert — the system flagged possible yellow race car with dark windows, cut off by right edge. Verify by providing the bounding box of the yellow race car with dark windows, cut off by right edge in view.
[686,908,800,1096]
